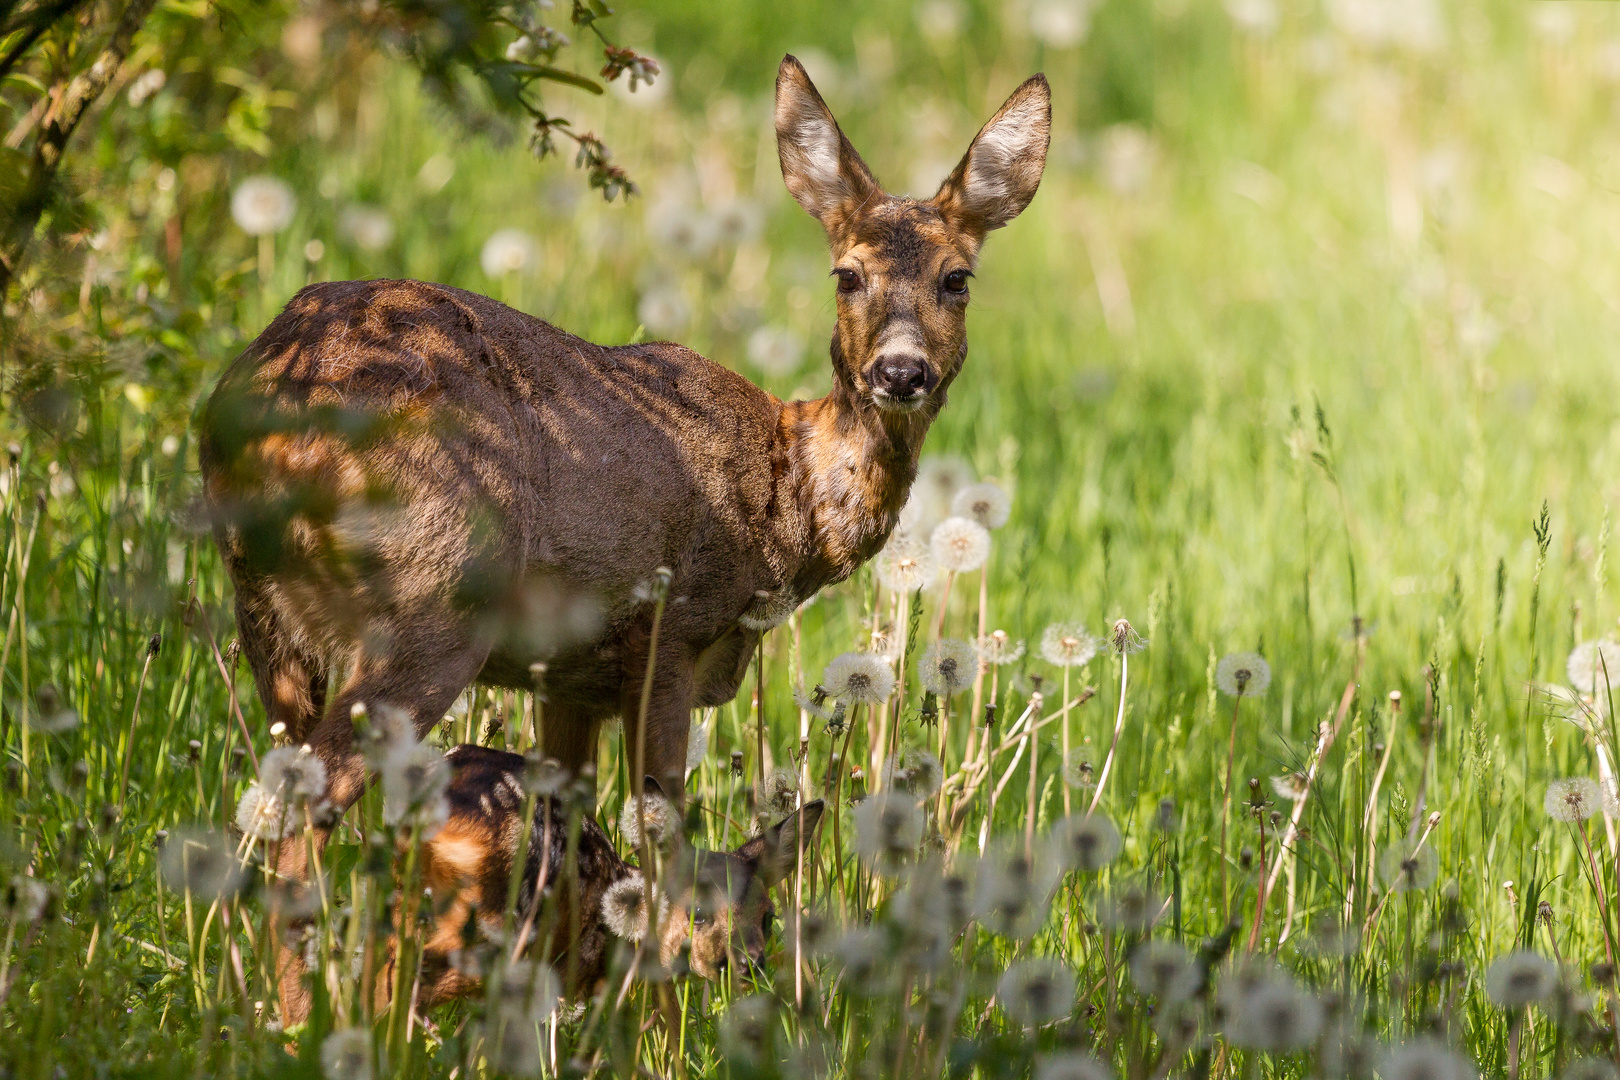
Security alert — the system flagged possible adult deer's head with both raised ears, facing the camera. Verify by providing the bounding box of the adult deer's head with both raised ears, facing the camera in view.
[776,57,1051,415]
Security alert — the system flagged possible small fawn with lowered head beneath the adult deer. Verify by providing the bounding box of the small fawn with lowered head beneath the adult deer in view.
[408,745,823,1009]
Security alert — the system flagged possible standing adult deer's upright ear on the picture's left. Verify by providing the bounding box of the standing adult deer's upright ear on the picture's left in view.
[776,57,881,233]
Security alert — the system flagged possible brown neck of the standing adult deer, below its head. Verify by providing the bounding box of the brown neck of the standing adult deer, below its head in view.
[781,358,944,593]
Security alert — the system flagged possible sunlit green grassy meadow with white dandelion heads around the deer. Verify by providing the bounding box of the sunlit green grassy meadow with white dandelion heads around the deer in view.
[0,0,1620,1080]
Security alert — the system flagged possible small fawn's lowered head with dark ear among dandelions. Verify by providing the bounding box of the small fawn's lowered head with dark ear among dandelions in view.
[641,800,825,978]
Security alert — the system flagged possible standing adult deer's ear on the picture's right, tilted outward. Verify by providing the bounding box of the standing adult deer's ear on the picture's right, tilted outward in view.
[933,74,1051,238]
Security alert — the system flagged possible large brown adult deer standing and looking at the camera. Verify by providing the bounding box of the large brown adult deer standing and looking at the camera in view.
[201,57,1051,1014]
